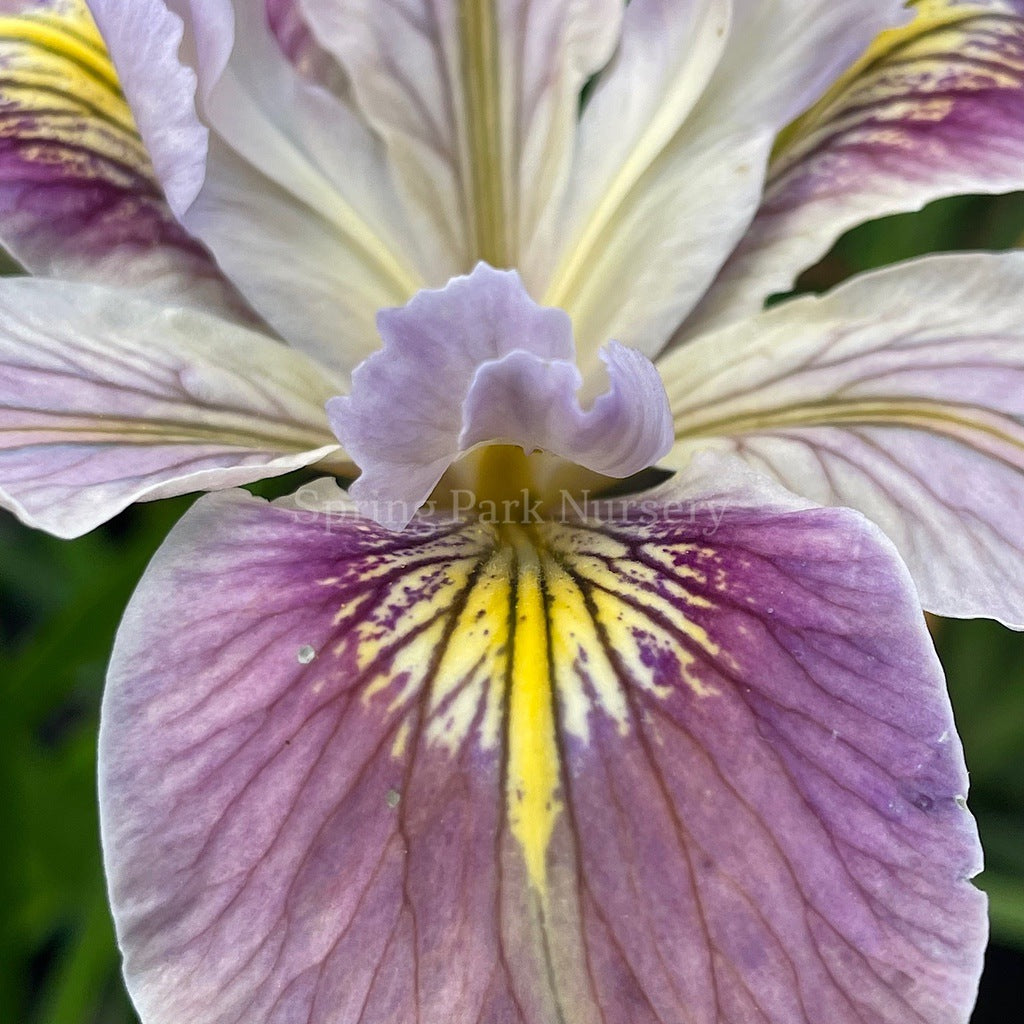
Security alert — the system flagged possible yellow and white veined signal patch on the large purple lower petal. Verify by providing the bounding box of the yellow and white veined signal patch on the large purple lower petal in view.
[337,522,745,913]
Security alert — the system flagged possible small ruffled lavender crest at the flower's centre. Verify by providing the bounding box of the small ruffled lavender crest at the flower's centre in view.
[328,263,673,528]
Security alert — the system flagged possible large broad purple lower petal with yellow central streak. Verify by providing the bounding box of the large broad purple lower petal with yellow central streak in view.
[100,479,985,1024]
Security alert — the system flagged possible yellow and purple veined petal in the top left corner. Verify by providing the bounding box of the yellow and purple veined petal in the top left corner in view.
[0,0,251,318]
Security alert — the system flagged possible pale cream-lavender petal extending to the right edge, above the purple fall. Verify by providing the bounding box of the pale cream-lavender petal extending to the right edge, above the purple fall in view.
[659,253,1024,628]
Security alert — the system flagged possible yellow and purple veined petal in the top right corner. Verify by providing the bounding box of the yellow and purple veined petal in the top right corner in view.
[681,0,1024,338]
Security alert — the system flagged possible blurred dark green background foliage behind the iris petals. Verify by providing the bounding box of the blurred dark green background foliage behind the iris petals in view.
[0,196,1024,1024]
